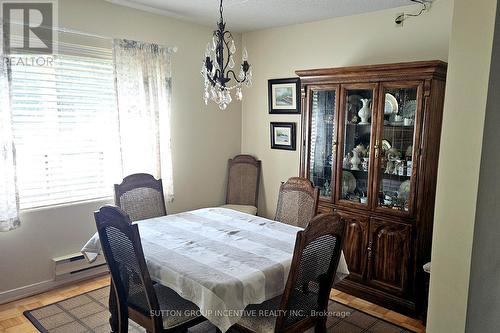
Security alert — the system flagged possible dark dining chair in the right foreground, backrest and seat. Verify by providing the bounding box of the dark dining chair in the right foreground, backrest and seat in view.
[235,214,345,333]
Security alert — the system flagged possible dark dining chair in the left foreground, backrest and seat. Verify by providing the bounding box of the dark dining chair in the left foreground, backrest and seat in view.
[94,205,205,333]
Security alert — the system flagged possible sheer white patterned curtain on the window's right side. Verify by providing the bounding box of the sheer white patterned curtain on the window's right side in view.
[114,40,175,202]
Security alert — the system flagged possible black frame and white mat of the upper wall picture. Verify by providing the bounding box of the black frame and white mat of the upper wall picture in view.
[267,77,300,114]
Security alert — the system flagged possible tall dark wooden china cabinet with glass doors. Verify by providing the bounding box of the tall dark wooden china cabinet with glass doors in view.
[296,61,446,317]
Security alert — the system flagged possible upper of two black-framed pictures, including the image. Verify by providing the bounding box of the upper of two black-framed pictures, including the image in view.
[267,78,300,114]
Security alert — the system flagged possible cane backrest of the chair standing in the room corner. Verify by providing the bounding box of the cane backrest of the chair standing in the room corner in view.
[226,155,261,207]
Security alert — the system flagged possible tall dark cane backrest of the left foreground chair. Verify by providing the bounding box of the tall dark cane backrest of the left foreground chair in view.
[94,205,162,327]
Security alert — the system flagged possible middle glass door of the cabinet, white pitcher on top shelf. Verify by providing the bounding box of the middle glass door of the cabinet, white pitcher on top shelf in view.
[338,84,376,206]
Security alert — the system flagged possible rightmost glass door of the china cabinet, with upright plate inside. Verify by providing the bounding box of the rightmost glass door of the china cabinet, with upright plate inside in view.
[376,83,421,215]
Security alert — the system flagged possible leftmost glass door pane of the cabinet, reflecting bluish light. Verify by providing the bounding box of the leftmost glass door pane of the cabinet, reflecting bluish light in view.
[308,89,337,200]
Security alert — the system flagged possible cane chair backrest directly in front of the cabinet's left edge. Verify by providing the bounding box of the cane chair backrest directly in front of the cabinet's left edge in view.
[274,177,319,228]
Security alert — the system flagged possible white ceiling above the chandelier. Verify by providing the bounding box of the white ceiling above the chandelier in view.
[106,0,412,32]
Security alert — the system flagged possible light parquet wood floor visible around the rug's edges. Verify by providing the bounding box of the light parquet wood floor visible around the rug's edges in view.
[0,276,425,333]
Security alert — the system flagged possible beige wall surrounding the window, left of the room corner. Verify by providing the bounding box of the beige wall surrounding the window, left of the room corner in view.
[0,0,241,297]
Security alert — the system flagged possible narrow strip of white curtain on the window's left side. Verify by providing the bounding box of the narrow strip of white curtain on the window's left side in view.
[0,59,20,231]
